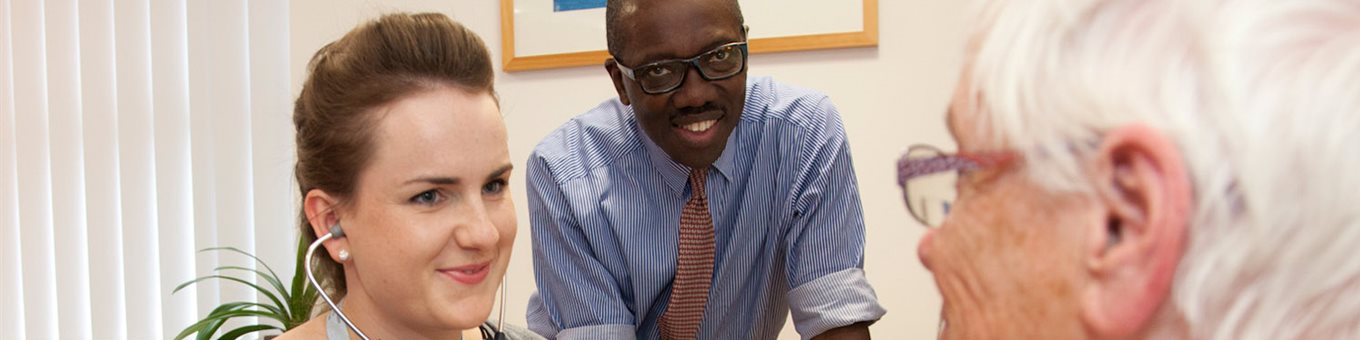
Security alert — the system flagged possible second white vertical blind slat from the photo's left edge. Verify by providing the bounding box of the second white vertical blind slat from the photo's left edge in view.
[45,0,92,339]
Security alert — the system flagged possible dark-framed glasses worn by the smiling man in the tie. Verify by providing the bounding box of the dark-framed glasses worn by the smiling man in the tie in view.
[615,41,747,94]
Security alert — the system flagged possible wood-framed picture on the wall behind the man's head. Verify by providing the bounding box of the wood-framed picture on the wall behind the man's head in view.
[500,0,879,72]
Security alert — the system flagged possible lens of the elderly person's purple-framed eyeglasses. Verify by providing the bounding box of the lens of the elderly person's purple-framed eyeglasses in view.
[902,148,959,227]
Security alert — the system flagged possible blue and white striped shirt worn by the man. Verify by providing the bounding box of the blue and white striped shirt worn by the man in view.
[528,78,884,339]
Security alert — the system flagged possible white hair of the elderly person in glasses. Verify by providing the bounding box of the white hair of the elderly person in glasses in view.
[964,0,1360,339]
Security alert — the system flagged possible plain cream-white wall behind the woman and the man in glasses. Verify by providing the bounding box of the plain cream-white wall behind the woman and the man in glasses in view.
[291,0,967,339]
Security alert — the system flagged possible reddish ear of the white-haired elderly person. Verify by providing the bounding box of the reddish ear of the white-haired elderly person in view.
[1081,125,1193,337]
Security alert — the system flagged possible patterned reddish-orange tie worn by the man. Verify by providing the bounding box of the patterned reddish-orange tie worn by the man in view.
[658,169,713,340]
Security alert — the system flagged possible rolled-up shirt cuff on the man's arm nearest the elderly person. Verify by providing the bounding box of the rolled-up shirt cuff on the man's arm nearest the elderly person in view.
[789,268,887,340]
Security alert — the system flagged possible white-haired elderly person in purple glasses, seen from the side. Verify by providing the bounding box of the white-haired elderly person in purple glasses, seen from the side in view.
[899,0,1360,339]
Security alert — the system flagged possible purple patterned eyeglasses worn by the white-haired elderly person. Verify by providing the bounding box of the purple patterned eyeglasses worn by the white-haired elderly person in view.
[898,144,1015,228]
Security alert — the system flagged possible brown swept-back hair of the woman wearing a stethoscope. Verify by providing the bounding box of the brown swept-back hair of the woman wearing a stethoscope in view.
[292,14,495,306]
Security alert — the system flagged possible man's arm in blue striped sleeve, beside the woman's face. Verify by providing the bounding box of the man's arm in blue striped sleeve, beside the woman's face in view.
[526,154,636,339]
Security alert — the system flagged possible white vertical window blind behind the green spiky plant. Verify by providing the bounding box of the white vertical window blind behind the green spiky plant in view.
[0,0,298,339]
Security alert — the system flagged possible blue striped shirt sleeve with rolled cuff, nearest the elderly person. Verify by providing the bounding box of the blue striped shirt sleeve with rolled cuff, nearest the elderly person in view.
[786,99,885,339]
